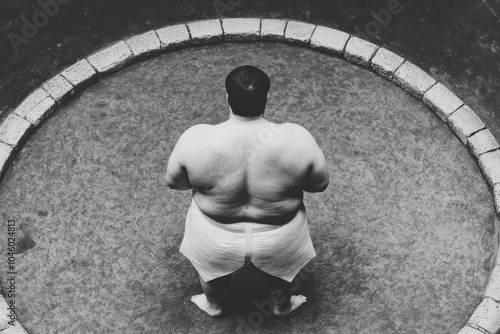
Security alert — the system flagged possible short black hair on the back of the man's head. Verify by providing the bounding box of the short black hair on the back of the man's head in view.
[226,65,271,117]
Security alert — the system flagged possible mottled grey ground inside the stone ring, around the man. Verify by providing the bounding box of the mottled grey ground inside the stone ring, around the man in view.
[0,44,495,334]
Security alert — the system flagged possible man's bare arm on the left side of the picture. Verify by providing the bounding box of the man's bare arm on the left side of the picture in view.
[166,133,193,190]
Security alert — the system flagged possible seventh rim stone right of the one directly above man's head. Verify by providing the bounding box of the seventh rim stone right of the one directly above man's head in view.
[422,82,464,122]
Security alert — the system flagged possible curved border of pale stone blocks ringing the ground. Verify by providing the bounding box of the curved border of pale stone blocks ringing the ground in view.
[0,18,500,334]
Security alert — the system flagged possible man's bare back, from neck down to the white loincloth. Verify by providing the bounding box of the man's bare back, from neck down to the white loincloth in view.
[169,115,328,224]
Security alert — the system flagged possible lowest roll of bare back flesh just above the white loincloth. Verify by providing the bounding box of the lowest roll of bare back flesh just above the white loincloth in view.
[194,194,305,225]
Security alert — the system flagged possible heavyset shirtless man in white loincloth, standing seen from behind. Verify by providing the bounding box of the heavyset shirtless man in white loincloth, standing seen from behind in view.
[167,66,329,316]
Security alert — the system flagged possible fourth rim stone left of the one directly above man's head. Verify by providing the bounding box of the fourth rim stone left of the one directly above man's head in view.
[87,41,132,74]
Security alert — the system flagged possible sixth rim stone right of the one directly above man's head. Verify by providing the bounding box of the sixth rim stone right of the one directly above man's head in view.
[392,61,436,99]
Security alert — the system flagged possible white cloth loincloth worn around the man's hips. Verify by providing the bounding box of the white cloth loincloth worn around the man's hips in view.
[180,199,316,282]
